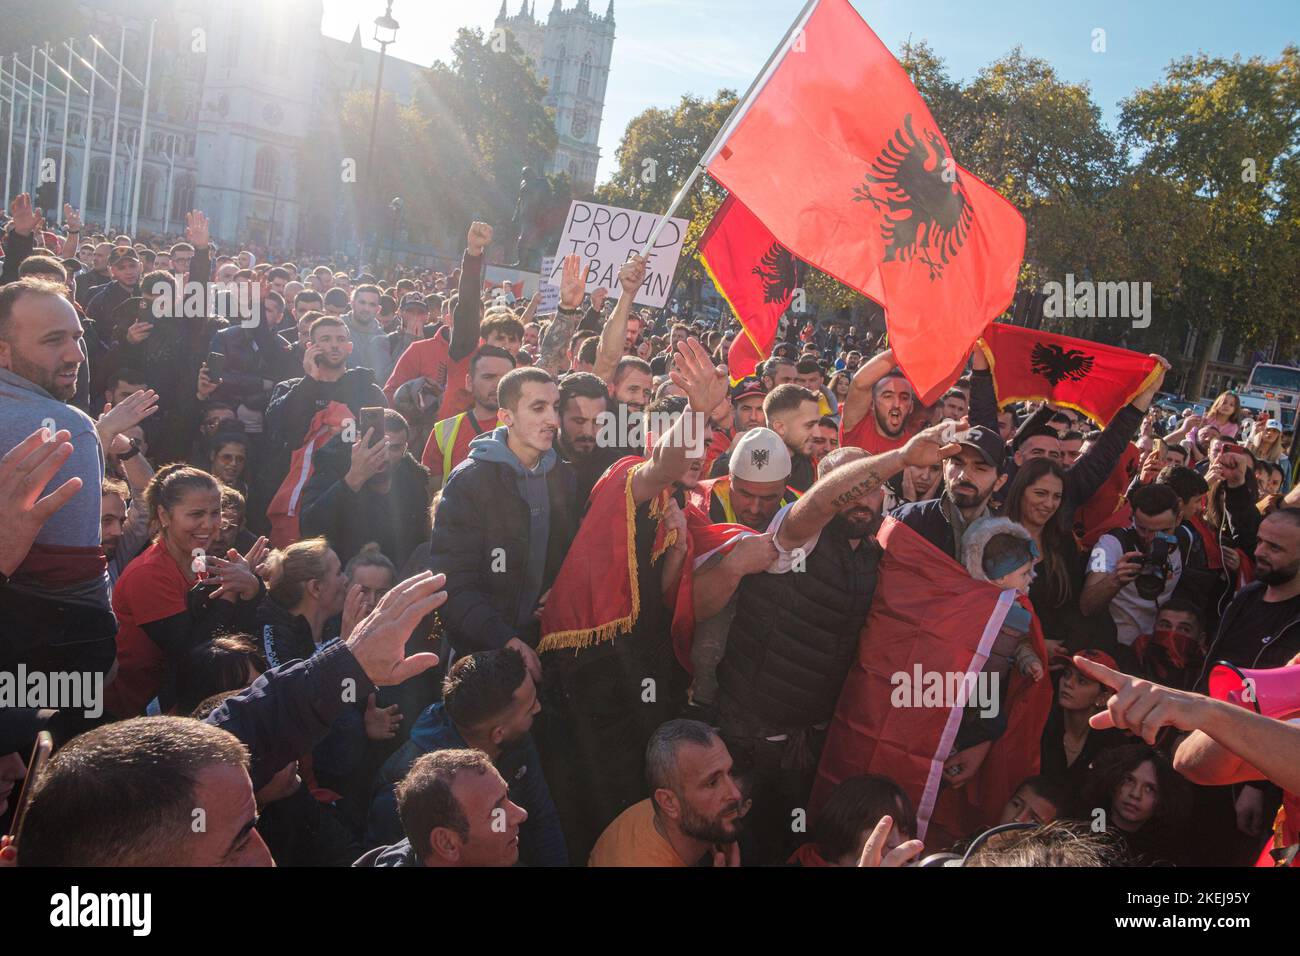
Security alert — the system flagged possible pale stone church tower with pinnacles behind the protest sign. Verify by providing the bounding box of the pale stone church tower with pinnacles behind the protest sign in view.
[495,0,614,190]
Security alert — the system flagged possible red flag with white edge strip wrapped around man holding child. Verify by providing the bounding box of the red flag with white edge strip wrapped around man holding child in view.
[811,518,1052,849]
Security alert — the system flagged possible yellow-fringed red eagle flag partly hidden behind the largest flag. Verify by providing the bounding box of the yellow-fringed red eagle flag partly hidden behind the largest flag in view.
[697,196,801,385]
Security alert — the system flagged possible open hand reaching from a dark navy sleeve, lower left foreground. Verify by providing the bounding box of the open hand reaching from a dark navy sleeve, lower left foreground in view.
[347,571,447,687]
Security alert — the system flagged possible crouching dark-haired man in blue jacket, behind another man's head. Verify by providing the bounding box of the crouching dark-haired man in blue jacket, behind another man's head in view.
[365,648,568,866]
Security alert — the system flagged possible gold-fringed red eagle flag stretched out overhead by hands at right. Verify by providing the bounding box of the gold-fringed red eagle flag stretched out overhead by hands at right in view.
[979,323,1160,424]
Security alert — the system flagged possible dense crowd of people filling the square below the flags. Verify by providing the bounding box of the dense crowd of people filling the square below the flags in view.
[0,188,1300,866]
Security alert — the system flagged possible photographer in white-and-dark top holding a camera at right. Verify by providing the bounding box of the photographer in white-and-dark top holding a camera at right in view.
[1079,484,1183,658]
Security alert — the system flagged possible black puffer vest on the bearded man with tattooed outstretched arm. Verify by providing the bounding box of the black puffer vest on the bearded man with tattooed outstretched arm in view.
[718,518,880,732]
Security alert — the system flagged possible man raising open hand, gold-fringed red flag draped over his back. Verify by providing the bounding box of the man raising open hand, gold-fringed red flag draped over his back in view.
[533,338,727,860]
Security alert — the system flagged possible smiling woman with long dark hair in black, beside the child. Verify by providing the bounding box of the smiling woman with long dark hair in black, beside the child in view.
[1004,458,1115,667]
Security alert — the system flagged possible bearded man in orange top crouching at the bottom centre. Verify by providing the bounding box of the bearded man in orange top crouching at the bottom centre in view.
[588,719,742,866]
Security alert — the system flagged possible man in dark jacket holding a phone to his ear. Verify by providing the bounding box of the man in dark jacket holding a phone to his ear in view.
[299,408,429,567]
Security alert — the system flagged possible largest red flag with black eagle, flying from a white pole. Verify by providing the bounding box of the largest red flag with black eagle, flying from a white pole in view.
[706,0,1024,403]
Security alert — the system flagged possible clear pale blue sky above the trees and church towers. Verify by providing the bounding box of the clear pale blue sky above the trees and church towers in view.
[324,0,1300,182]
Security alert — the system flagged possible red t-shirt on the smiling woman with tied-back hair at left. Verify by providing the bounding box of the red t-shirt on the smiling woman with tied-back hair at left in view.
[104,540,190,718]
